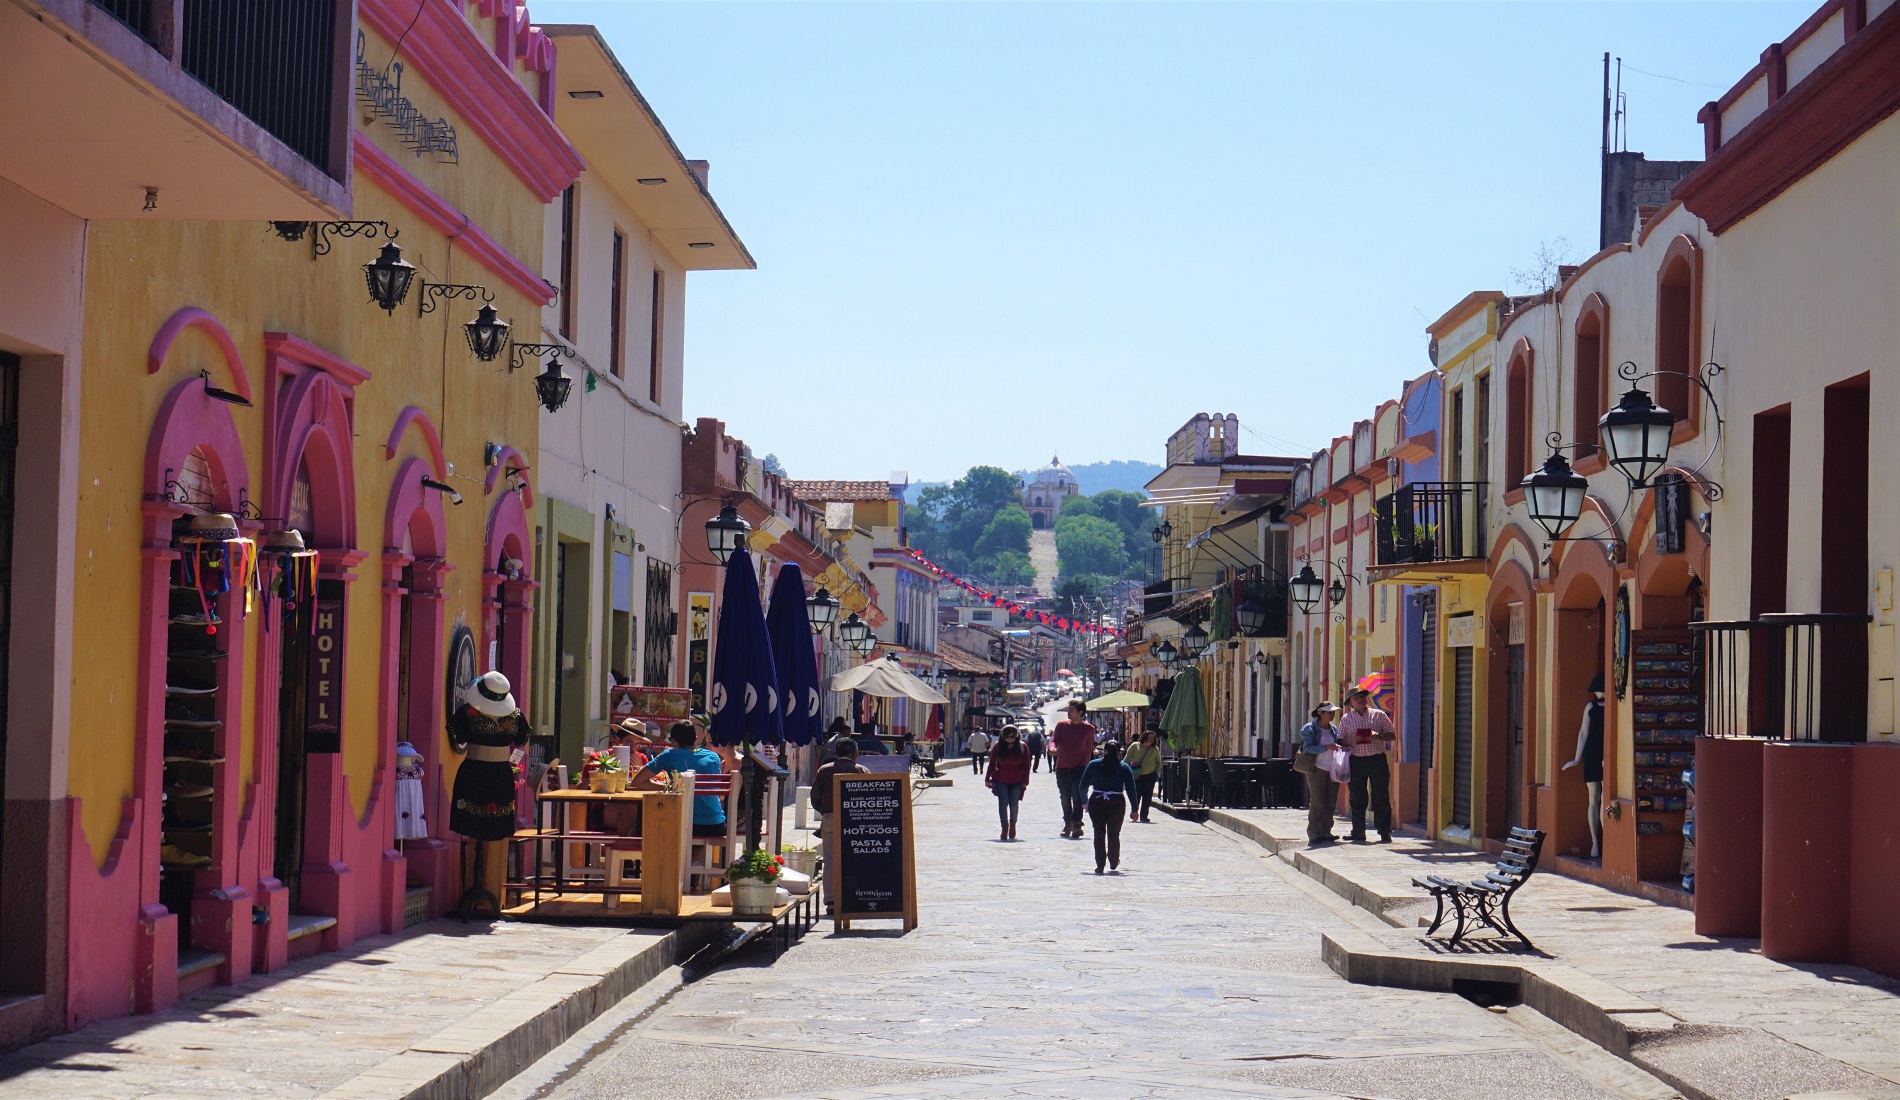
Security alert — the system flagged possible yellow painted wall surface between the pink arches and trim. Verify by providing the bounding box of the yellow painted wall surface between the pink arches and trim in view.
[70,60,543,861]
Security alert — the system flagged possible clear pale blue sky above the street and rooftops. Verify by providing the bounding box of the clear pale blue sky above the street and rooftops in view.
[532,0,1813,481]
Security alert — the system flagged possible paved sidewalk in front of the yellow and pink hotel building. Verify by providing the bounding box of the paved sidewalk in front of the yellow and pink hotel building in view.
[0,920,699,1100]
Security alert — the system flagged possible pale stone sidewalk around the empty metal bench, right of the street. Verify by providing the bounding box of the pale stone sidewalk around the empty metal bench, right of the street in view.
[1208,809,1900,1100]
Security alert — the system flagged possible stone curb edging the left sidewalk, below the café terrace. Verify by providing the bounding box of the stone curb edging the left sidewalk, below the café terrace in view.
[323,925,705,1100]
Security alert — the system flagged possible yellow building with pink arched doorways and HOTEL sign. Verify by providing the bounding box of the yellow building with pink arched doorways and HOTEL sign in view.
[68,0,581,1024]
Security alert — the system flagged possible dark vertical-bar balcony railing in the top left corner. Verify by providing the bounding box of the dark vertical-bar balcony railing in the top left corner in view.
[91,0,346,179]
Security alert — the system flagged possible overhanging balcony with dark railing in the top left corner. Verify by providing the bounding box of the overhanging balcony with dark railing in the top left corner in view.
[0,0,353,220]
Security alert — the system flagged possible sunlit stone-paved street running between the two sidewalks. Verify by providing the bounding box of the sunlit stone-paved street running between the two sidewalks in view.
[500,771,1672,1100]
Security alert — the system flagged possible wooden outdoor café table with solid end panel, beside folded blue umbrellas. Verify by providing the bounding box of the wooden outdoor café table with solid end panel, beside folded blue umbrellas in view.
[521,788,694,916]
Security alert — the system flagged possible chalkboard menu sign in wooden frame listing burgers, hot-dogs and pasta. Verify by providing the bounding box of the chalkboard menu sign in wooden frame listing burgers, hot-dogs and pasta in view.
[825,773,918,929]
